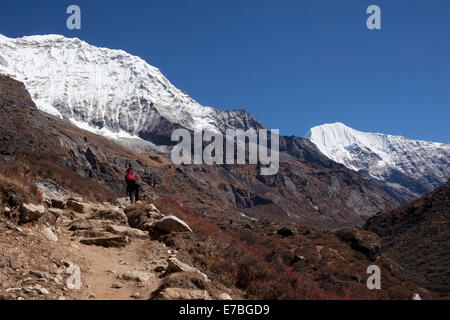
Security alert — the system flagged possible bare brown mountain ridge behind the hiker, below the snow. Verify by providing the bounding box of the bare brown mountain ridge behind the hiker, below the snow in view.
[0,77,397,229]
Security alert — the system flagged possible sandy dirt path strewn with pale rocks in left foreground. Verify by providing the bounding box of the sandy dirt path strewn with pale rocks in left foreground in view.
[0,190,218,300]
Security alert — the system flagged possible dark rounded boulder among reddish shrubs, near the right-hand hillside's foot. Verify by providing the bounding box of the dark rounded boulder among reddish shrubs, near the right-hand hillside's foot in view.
[334,227,381,261]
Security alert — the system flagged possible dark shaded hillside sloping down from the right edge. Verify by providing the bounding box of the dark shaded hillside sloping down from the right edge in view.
[364,181,450,297]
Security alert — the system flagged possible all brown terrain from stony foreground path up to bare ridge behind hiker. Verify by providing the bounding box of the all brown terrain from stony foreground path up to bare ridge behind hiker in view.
[0,77,440,300]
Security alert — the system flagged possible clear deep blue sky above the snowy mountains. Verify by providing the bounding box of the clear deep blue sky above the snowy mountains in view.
[0,0,450,143]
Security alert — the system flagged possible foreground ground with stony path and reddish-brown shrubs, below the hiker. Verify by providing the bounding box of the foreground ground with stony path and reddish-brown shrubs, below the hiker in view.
[0,166,433,300]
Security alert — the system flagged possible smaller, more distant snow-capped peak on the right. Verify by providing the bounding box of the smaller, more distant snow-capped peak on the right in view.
[306,123,450,202]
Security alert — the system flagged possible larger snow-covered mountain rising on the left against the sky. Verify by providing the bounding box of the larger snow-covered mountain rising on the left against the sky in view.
[0,35,262,149]
